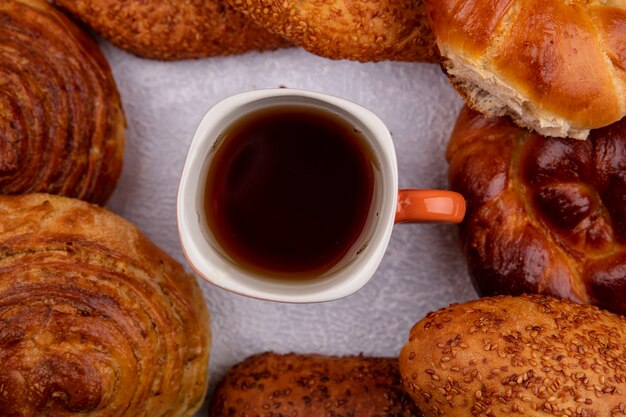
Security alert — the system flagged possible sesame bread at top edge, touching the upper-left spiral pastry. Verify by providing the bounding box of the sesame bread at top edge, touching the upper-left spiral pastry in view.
[54,0,288,60]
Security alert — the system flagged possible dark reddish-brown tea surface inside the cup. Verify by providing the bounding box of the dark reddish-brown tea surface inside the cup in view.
[204,105,377,279]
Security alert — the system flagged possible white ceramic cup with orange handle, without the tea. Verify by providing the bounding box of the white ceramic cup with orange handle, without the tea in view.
[177,88,465,303]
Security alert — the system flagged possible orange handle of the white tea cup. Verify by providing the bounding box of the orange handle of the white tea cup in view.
[395,190,465,223]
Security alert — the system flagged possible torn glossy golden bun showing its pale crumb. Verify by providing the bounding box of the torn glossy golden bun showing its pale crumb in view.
[425,0,626,139]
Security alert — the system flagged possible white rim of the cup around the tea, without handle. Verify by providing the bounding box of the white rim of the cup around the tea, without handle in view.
[176,88,398,303]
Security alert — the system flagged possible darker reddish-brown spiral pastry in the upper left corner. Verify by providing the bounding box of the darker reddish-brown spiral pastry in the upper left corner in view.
[0,0,126,204]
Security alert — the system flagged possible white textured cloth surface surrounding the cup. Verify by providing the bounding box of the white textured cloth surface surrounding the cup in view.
[102,42,476,416]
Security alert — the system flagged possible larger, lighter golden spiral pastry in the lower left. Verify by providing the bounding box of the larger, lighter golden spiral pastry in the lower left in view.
[0,194,210,417]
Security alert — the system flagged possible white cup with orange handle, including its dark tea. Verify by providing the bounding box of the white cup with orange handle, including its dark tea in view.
[176,88,465,303]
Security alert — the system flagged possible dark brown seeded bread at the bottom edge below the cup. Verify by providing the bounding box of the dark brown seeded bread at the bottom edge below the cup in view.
[209,352,421,417]
